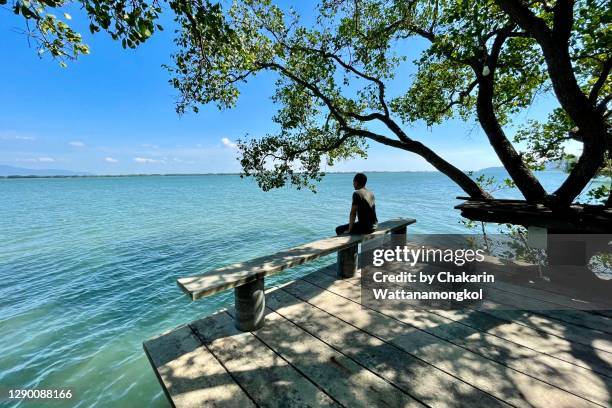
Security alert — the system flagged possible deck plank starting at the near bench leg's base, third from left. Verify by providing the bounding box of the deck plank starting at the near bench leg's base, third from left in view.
[227,302,423,407]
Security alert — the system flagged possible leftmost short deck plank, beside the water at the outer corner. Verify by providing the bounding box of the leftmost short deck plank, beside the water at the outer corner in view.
[143,326,255,408]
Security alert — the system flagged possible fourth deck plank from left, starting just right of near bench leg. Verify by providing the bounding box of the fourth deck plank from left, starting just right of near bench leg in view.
[268,285,508,408]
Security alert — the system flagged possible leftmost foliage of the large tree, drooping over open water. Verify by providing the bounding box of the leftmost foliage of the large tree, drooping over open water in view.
[169,1,400,190]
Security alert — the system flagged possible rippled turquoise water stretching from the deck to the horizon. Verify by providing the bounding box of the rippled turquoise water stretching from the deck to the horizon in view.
[0,172,584,407]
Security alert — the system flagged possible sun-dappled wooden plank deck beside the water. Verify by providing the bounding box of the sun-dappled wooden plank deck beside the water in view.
[144,266,612,408]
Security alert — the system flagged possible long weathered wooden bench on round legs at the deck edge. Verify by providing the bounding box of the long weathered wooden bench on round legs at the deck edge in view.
[177,219,416,331]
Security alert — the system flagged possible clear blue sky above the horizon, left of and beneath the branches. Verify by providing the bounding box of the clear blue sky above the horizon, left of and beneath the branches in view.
[0,3,552,174]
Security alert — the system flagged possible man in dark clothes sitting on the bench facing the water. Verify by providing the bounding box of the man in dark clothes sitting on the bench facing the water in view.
[336,173,378,235]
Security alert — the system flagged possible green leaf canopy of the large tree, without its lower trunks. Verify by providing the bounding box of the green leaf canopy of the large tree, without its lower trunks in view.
[165,0,611,194]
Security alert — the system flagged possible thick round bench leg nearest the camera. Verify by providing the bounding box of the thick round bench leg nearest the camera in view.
[234,278,266,331]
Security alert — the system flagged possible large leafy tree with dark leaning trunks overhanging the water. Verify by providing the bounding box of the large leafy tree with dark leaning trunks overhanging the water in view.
[5,0,612,206]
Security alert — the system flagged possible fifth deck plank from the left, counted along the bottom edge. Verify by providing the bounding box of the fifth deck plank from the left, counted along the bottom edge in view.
[298,277,595,407]
